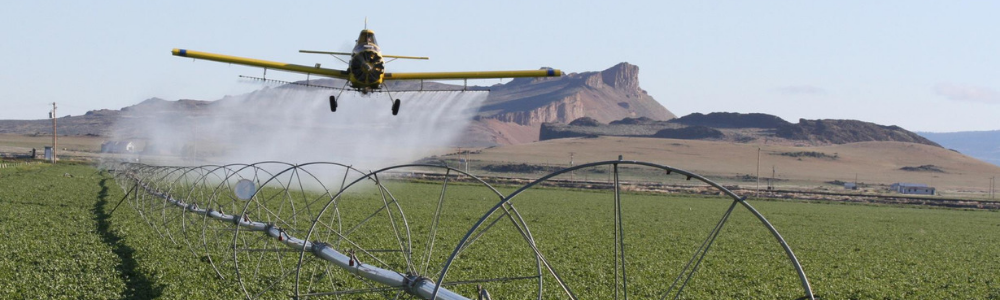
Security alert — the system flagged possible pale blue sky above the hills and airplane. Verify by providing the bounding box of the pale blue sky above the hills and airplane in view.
[0,1,1000,132]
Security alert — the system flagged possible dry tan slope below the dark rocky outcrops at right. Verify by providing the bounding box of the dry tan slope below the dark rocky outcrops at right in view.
[456,137,1000,197]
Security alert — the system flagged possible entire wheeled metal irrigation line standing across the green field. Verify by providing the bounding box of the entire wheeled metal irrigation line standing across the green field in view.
[114,159,815,299]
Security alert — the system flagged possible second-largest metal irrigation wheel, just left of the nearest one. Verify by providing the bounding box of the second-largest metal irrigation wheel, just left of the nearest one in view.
[294,164,541,299]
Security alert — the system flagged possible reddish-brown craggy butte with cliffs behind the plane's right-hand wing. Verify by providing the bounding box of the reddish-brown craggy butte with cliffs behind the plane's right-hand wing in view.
[476,63,675,144]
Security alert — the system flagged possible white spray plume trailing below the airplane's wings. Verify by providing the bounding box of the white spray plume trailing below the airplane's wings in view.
[114,85,488,169]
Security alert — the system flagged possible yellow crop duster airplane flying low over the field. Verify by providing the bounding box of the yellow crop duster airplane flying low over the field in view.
[171,26,562,115]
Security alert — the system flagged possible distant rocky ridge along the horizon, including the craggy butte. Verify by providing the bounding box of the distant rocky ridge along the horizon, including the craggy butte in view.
[0,63,952,151]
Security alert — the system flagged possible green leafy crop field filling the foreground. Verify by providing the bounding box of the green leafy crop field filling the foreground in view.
[0,165,1000,299]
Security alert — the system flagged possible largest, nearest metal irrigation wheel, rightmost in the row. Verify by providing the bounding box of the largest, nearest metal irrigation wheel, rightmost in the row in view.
[435,160,814,299]
